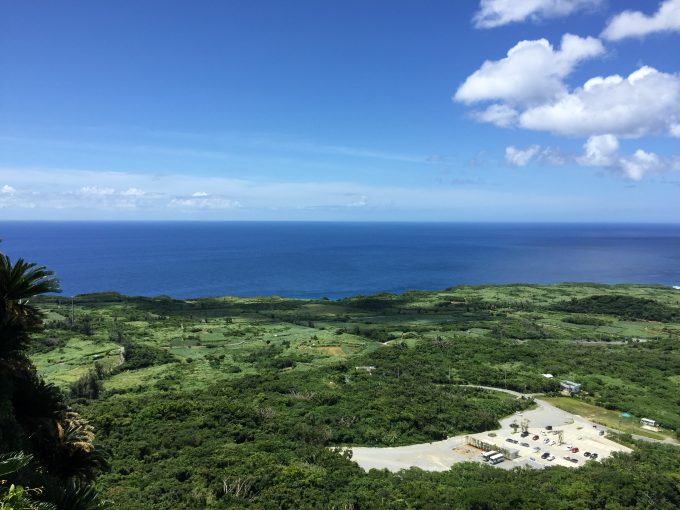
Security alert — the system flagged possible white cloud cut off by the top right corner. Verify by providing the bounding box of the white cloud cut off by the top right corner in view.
[602,0,680,41]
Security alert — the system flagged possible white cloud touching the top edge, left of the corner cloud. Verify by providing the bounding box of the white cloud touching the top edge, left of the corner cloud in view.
[473,0,602,28]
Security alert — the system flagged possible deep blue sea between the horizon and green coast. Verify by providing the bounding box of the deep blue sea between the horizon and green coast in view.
[0,222,680,299]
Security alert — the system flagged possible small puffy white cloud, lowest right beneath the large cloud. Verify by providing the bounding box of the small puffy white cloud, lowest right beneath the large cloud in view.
[577,134,671,181]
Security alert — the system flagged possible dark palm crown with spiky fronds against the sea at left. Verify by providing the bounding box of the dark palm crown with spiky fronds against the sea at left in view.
[0,253,60,358]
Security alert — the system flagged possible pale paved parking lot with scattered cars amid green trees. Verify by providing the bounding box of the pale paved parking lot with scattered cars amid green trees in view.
[352,392,631,471]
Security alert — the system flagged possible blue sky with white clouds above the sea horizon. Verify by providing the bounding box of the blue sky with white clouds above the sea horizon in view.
[0,0,680,222]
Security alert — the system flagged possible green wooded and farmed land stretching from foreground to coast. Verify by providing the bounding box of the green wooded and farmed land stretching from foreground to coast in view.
[0,256,680,510]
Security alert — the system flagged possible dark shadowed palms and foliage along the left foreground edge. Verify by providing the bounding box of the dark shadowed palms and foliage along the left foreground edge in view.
[0,254,107,510]
